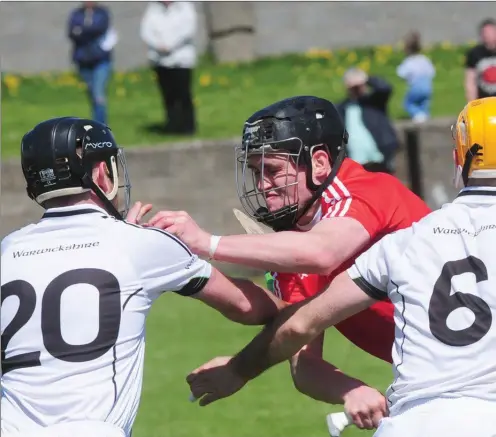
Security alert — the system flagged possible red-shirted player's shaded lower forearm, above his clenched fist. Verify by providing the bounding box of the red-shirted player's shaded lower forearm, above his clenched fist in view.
[291,351,364,404]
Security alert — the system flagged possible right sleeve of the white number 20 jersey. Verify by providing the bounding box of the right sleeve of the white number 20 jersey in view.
[128,228,212,298]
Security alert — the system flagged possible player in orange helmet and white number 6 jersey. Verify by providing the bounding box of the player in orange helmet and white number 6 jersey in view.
[184,97,496,437]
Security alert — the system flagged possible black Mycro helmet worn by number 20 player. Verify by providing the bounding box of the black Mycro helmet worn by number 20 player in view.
[21,117,131,219]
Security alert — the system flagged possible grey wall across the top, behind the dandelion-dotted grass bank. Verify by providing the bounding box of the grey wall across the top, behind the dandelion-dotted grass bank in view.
[0,1,492,73]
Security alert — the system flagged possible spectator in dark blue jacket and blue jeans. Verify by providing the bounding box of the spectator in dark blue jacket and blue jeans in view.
[68,2,117,123]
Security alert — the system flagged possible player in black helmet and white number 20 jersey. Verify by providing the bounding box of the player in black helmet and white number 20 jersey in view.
[1,117,279,437]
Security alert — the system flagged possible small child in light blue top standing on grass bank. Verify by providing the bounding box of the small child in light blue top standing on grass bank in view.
[396,32,436,122]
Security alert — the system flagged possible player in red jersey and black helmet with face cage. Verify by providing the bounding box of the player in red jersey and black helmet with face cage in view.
[148,96,430,429]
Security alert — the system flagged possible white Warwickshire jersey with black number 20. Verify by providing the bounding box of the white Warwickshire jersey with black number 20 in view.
[1,205,211,436]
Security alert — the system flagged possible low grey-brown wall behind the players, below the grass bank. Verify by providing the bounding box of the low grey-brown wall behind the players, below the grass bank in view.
[0,119,455,272]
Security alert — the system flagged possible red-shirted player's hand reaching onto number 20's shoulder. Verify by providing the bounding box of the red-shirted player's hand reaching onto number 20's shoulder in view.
[146,211,211,257]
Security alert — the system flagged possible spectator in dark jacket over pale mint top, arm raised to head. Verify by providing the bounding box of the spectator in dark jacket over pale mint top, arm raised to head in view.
[338,68,399,173]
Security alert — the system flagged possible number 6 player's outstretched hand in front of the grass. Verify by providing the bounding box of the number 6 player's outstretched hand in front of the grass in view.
[186,357,246,407]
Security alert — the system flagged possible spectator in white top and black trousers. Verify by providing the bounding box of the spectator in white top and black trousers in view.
[140,1,197,134]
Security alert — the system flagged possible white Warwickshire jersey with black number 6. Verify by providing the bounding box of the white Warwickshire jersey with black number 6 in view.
[348,188,496,414]
